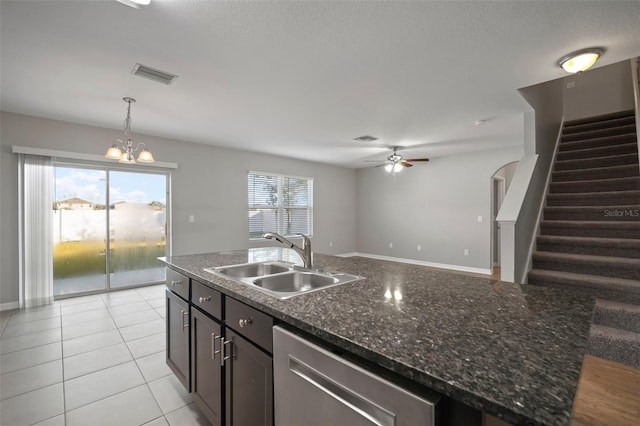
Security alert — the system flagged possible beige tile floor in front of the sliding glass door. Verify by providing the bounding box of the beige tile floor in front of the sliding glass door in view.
[0,285,209,426]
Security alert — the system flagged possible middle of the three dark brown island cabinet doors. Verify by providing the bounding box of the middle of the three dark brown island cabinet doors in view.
[191,309,223,426]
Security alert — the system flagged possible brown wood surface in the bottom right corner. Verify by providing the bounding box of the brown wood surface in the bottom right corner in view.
[571,355,640,426]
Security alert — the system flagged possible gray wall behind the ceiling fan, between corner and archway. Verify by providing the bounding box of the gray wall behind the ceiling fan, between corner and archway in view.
[357,146,523,269]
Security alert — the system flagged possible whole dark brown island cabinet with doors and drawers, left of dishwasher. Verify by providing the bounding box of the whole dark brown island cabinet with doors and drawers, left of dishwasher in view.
[166,269,274,426]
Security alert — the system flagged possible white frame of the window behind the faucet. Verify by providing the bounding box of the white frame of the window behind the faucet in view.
[247,170,313,241]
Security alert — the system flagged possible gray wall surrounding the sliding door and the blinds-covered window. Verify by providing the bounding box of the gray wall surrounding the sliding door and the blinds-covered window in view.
[0,113,356,303]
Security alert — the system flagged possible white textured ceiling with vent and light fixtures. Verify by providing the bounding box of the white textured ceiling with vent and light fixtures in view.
[0,0,640,167]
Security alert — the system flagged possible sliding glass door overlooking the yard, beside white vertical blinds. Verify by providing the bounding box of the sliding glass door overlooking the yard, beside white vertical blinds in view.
[53,165,168,296]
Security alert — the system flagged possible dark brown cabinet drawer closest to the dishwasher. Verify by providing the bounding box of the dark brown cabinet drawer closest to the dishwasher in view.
[225,297,273,352]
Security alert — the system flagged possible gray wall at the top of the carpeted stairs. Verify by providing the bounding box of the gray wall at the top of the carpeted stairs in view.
[564,61,633,121]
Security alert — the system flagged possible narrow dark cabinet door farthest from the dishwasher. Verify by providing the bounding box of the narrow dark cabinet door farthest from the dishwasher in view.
[166,290,191,391]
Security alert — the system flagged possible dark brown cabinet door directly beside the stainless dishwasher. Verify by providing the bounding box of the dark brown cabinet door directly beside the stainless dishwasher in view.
[224,328,273,426]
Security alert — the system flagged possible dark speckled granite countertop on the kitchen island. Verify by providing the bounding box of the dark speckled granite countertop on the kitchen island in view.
[161,248,594,425]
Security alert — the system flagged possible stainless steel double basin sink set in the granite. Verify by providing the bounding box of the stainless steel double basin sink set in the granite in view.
[205,261,363,299]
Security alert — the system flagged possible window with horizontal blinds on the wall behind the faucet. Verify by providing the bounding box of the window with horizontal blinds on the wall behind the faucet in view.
[248,172,313,239]
